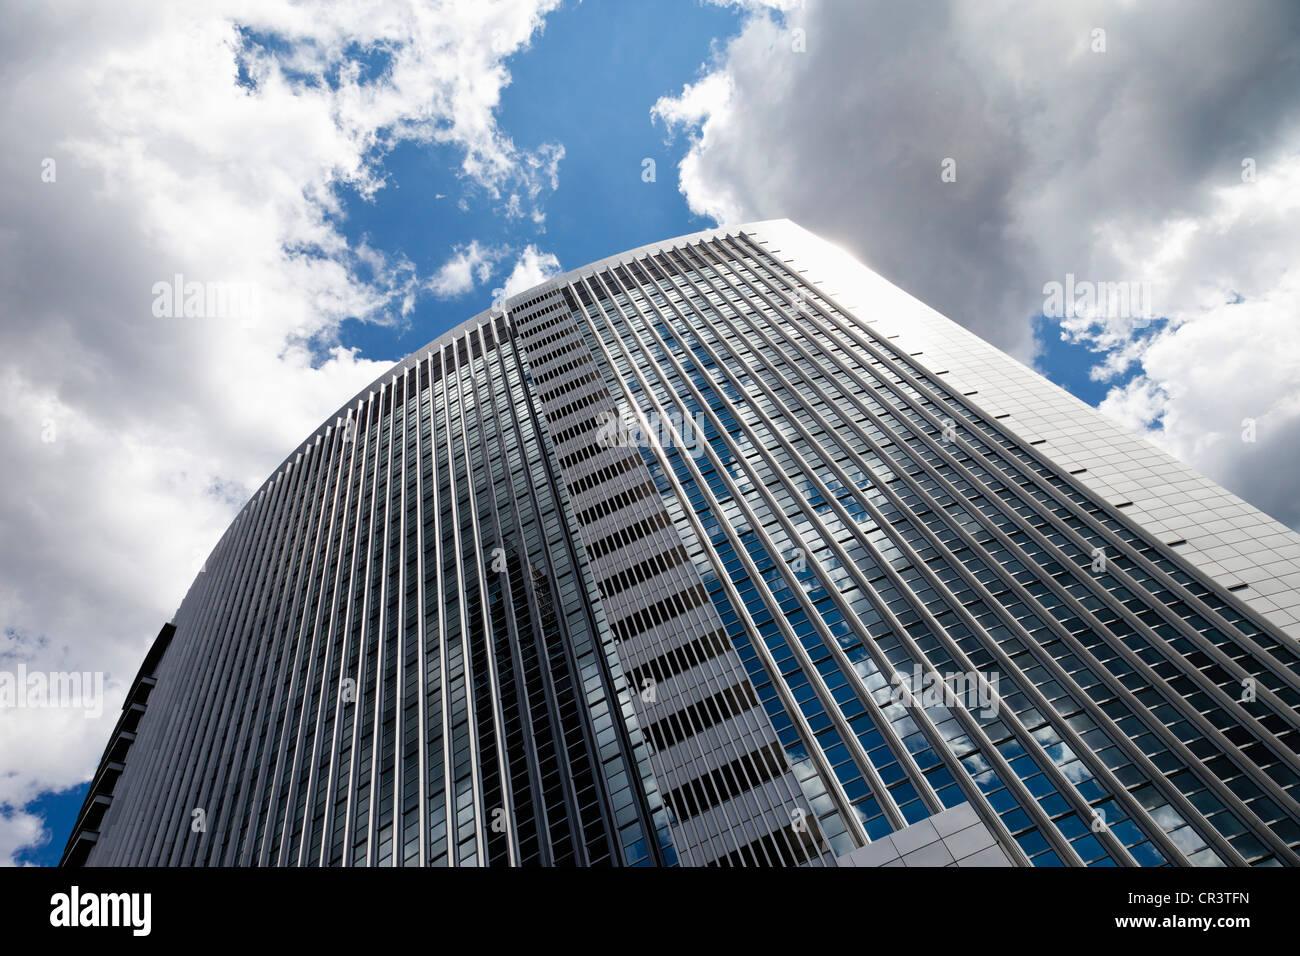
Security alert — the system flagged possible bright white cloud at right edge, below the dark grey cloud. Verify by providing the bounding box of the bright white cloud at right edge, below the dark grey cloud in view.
[1078,159,1300,527]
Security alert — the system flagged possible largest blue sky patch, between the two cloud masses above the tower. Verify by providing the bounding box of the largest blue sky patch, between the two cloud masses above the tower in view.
[330,0,740,360]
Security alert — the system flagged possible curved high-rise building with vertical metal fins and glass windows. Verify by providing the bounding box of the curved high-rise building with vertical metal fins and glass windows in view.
[65,221,1300,866]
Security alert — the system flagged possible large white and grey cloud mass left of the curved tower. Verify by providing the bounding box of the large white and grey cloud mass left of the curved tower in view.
[0,0,563,862]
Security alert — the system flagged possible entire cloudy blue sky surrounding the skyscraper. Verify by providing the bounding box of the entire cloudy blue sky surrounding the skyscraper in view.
[10,0,1300,864]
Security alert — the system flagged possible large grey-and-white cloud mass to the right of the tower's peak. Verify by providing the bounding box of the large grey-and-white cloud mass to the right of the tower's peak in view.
[651,0,1300,525]
